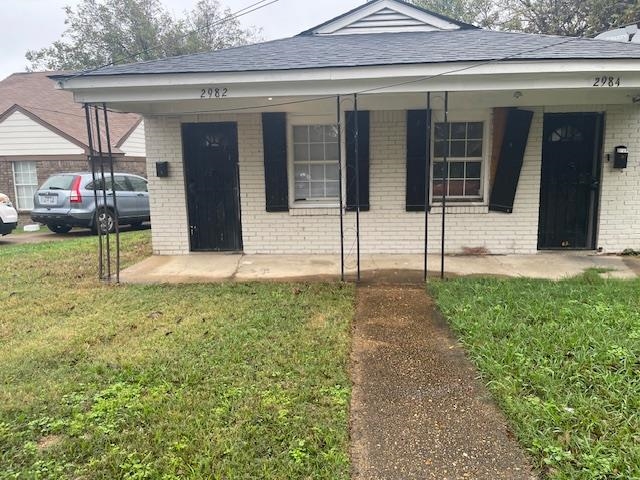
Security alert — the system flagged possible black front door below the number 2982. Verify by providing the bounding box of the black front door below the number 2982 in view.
[182,123,242,252]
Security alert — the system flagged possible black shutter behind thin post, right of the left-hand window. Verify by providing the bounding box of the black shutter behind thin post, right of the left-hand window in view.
[345,111,369,212]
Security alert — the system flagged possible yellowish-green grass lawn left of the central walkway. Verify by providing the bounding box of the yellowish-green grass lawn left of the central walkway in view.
[0,232,354,480]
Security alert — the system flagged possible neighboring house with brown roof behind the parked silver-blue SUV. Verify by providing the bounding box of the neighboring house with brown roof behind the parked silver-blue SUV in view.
[0,72,146,217]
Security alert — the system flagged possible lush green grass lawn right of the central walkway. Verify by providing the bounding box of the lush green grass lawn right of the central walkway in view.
[430,272,640,479]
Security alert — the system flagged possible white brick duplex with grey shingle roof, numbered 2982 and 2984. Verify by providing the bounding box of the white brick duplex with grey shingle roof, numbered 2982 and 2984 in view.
[57,0,640,254]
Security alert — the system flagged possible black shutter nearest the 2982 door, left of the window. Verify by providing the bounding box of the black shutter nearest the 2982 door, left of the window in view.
[262,113,289,212]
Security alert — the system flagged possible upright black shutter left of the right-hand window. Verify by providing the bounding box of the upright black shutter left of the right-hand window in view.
[406,110,428,212]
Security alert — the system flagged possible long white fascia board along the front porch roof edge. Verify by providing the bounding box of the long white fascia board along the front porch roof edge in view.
[59,59,640,91]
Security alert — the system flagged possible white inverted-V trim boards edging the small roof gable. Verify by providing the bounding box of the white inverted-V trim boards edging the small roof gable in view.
[313,0,460,35]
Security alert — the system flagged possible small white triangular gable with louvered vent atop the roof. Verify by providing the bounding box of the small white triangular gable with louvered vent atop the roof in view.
[301,0,475,35]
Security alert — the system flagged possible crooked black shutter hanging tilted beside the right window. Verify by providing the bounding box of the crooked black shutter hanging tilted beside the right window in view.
[489,109,533,213]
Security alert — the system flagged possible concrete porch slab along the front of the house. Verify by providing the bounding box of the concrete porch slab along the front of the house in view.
[121,252,636,283]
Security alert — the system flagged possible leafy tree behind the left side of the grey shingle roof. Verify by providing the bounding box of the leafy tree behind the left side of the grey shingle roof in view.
[26,0,256,70]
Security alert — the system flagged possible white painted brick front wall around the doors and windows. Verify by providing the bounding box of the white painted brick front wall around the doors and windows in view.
[145,106,640,255]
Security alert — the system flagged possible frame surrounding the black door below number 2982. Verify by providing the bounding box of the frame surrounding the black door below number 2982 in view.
[180,121,244,253]
